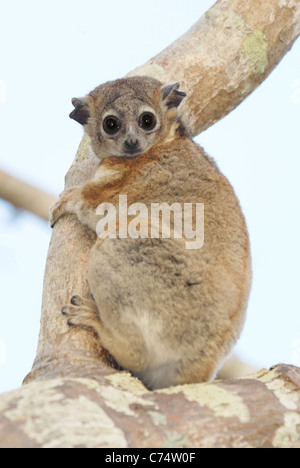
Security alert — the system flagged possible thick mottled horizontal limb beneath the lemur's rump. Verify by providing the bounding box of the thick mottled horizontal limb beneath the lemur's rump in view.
[0,364,300,453]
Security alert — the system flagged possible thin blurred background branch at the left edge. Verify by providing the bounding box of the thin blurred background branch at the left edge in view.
[0,171,56,221]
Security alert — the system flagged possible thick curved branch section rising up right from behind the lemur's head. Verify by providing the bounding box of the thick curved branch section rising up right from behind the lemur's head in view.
[129,0,300,136]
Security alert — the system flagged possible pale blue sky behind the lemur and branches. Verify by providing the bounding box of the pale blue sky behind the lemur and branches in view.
[0,0,300,392]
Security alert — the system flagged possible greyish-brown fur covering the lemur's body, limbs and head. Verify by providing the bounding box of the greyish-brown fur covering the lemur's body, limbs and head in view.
[51,78,251,388]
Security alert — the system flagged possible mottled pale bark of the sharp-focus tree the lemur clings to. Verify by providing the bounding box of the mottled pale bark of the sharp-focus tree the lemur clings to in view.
[0,0,300,447]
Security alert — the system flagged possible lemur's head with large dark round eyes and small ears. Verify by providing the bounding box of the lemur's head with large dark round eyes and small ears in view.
[70,77,186,159]
